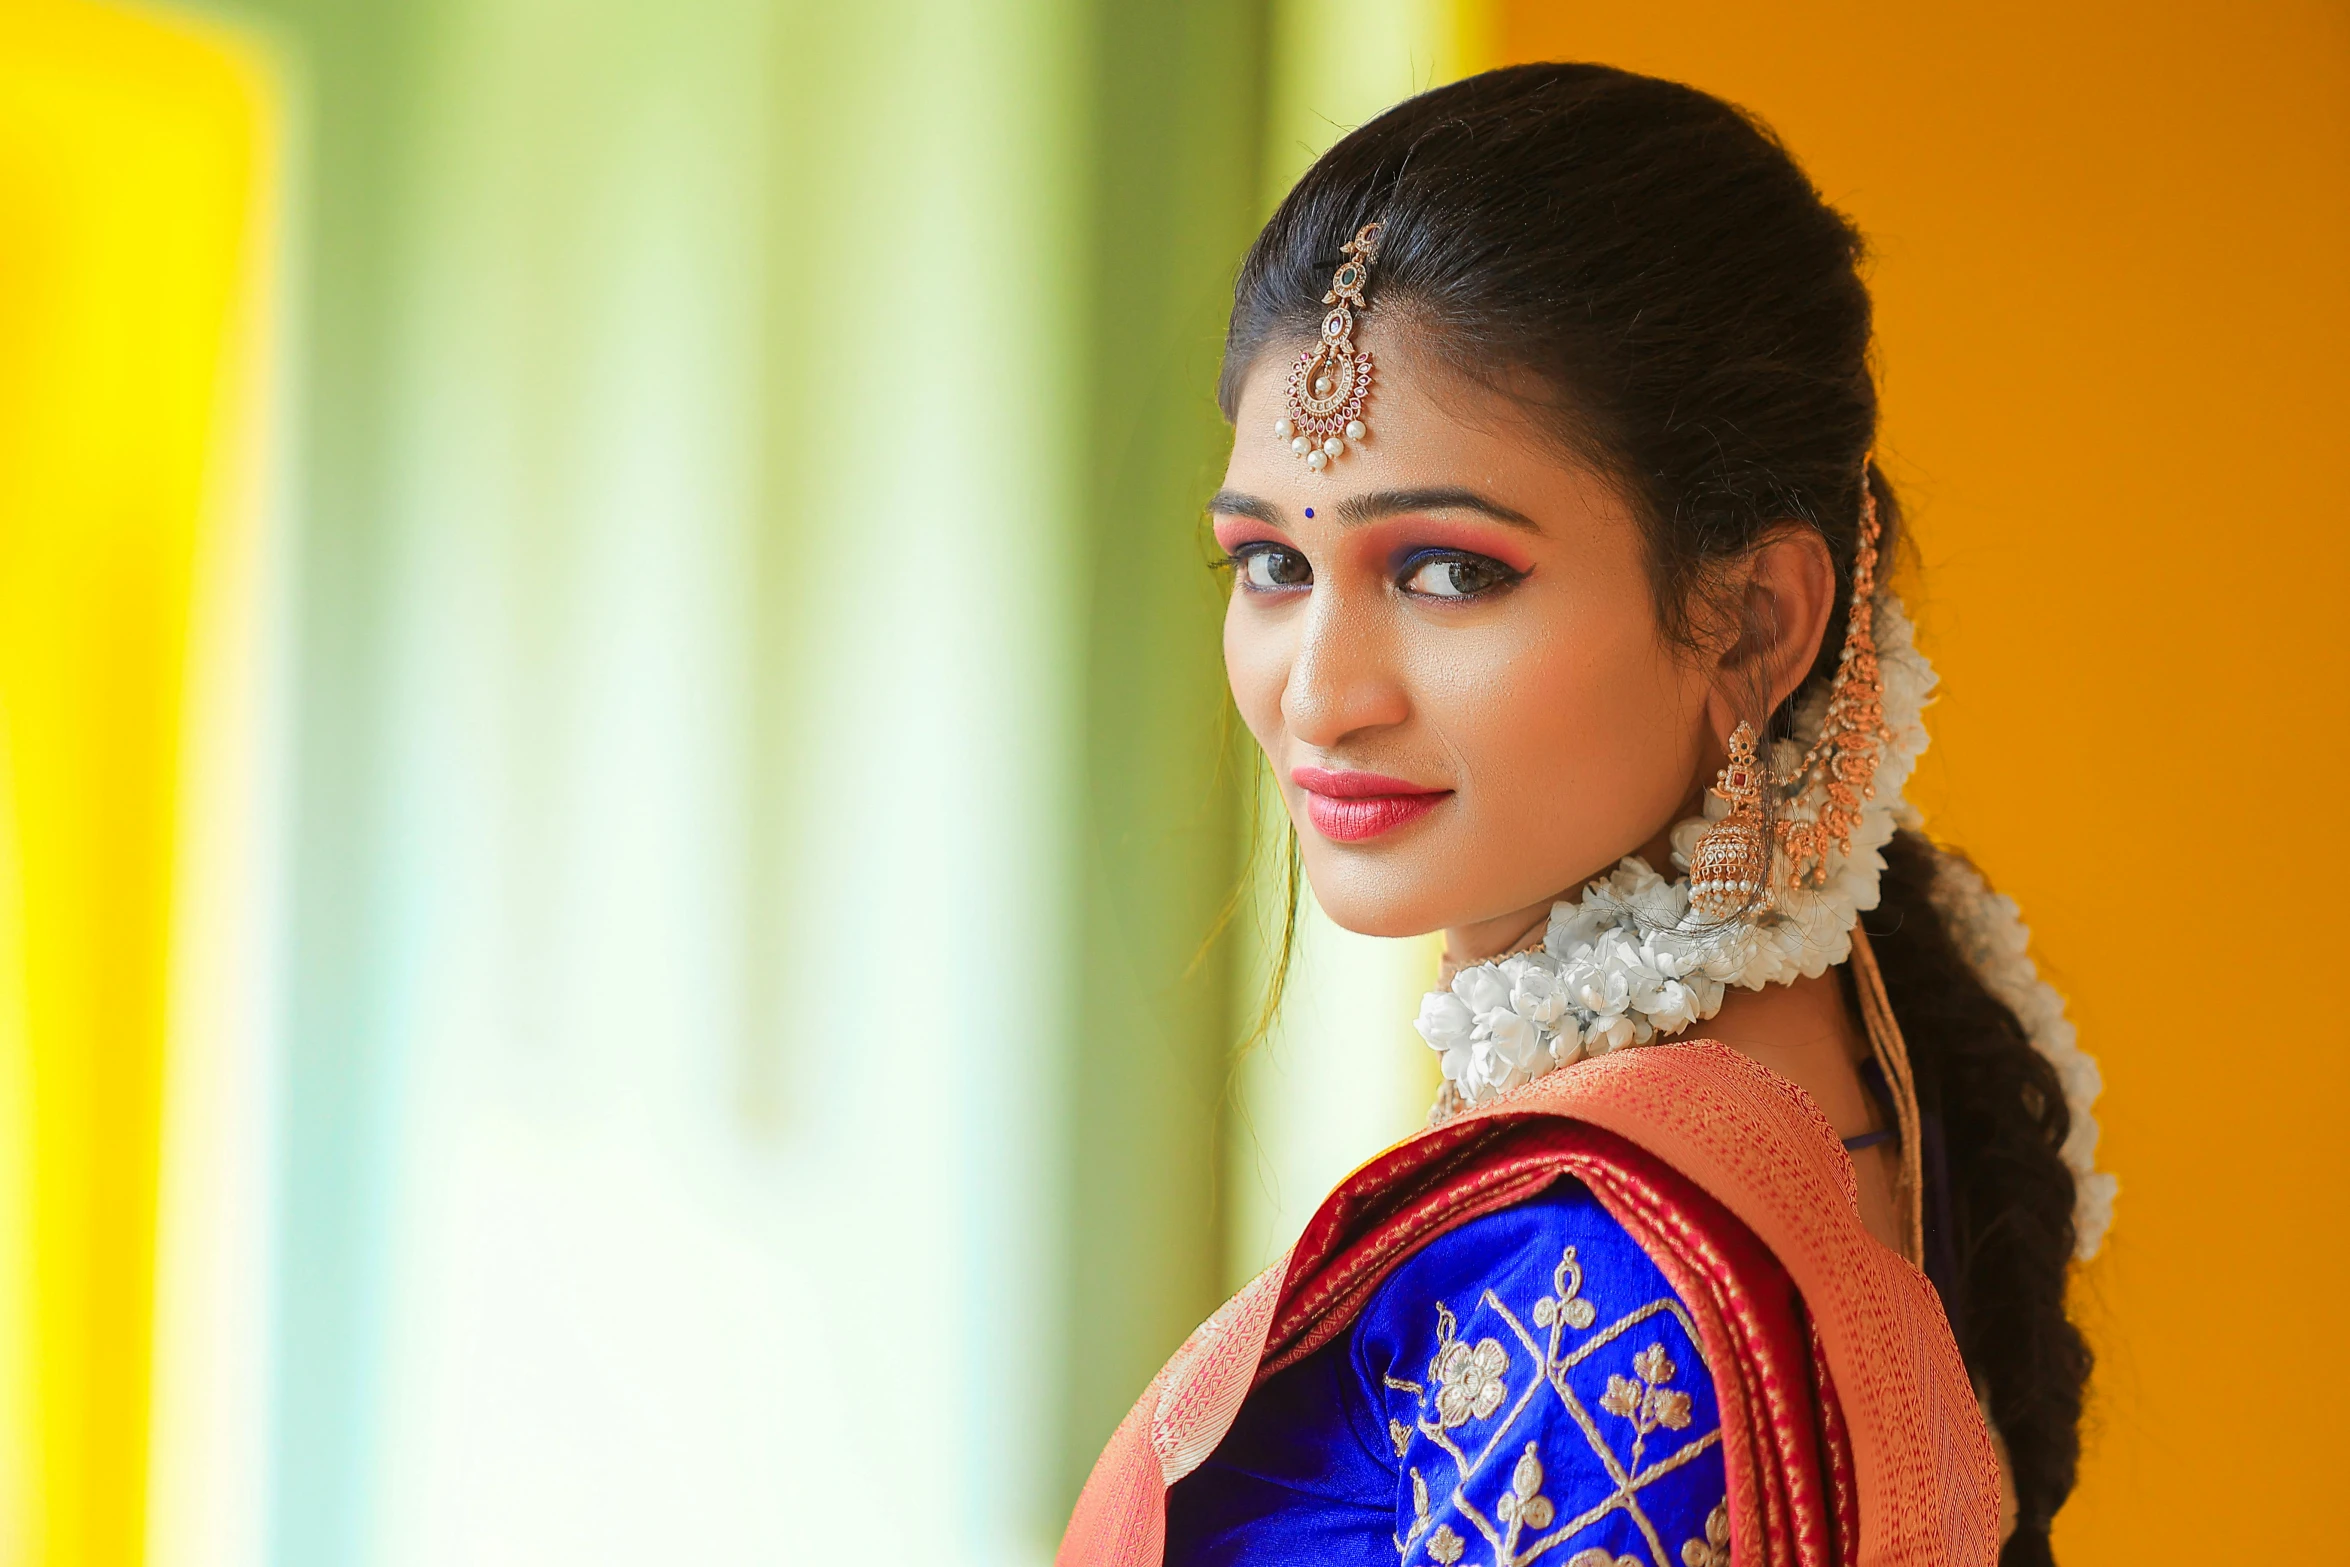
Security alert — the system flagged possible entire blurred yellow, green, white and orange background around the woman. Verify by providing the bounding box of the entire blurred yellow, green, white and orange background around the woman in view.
[0,0,2350,1567]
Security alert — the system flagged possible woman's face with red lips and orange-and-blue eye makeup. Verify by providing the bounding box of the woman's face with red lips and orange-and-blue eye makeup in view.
[1210,327,1718,935]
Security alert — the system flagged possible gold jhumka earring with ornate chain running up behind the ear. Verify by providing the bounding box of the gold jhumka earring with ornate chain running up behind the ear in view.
[1690,458,1889,919]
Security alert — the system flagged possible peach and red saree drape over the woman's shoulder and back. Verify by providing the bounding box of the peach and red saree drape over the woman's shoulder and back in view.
[1058,1043,2000,1567]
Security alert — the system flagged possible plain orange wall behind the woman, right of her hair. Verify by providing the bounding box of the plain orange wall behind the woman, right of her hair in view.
[1495,0,2350,1567]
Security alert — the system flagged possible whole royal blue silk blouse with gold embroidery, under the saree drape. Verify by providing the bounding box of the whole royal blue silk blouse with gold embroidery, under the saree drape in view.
[1166,1179,1730,1567]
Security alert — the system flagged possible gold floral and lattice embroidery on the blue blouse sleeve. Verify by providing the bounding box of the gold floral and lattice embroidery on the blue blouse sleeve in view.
[1387,1245,1730,1567]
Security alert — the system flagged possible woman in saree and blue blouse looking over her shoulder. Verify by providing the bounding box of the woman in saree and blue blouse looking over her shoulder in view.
[1062,66,2110,1567]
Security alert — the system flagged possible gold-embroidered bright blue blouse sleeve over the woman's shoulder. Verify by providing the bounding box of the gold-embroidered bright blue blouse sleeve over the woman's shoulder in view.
[1351,1182,1727,1567]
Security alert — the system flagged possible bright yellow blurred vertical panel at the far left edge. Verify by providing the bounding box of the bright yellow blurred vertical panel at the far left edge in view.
[0,5,263,1567]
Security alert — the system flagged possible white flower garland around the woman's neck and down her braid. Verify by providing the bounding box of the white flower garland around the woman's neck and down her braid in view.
[1417,594,2115,1257]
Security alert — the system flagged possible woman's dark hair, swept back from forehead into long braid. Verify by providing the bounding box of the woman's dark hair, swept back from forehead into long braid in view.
[1220,63,2089,1567]
